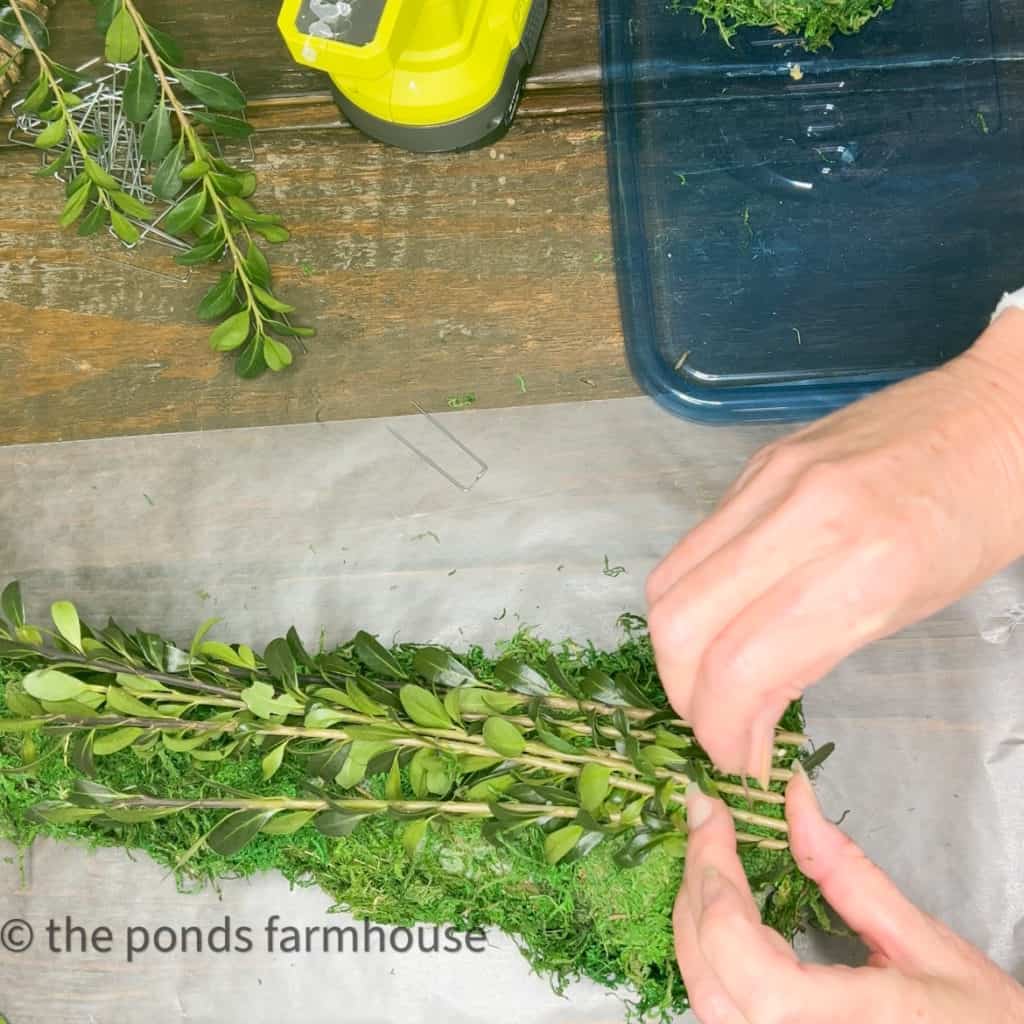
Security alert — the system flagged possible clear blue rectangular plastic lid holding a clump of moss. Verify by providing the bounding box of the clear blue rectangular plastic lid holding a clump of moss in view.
[601,0,1024,423]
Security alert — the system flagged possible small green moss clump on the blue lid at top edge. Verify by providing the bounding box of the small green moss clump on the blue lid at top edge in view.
[671,0,893,50]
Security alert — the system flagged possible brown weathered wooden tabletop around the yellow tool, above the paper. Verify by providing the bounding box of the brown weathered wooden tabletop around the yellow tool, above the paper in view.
[0,0,636,443]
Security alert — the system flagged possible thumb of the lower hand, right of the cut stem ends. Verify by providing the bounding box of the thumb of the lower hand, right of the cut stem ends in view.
[785,761,950,972]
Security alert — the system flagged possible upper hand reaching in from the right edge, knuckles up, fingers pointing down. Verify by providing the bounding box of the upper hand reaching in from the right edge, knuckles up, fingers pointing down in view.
[647,309,1024,781]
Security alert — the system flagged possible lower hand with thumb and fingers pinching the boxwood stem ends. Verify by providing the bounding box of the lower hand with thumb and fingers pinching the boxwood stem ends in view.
[673,770,1024,1024]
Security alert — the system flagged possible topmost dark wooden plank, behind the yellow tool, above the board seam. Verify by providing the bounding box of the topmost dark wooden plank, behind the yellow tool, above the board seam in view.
[29,0,598,99]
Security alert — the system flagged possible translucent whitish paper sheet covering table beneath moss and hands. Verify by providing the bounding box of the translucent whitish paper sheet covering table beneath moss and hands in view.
[0,399,1024,1024]
